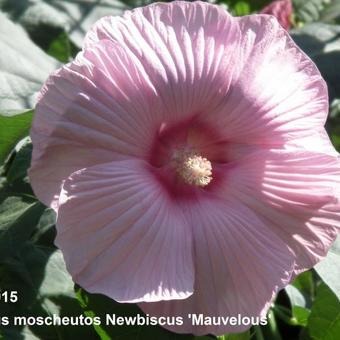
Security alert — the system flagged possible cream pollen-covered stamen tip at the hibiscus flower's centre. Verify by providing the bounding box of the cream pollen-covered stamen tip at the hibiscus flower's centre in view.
[176,154,212,187]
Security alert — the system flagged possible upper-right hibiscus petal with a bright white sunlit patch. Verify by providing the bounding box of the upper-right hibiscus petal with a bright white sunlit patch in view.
[202,15,328,145]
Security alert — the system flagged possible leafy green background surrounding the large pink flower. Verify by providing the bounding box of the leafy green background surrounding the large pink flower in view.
[0,0,340,340]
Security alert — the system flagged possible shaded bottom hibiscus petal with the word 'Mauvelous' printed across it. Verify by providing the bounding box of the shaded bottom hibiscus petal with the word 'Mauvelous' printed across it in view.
[140,198,294,335]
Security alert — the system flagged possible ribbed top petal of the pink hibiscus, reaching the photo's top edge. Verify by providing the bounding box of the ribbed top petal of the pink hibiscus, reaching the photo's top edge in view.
[85,1,240,120]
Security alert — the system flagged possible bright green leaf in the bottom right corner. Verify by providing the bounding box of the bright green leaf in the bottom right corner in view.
[307,284,340,340]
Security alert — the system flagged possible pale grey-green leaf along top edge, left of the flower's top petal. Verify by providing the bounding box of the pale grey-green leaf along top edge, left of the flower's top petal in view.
[0,0,130,47]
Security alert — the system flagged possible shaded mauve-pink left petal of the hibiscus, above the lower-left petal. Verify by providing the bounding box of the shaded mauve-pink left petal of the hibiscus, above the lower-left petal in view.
[29,41,158,209]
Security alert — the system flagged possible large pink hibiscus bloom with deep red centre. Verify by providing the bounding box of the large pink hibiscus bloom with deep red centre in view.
[30,2,340,334]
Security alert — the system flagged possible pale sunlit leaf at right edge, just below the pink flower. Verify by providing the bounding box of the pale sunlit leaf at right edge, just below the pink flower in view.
[314,237,340,301]
